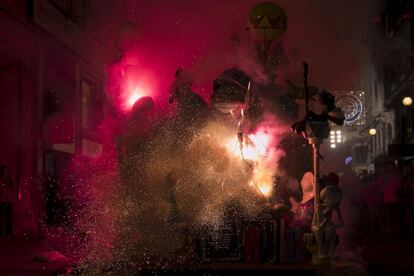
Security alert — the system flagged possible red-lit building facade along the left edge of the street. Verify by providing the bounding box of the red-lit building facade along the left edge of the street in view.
[0,0,105,236]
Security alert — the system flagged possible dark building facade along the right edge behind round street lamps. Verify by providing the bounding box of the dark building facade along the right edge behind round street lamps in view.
[364,0,414,170]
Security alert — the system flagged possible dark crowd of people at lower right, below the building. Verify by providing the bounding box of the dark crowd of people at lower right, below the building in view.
[354,161,414,236]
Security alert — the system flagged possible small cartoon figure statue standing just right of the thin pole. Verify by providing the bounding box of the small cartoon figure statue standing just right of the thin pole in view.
[312,172,344,260]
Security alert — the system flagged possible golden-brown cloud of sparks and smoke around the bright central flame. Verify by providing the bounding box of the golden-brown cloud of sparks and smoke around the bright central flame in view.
[73,108,286,270]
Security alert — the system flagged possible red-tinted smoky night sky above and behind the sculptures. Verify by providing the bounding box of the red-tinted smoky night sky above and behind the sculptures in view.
[93,0,375,102]
